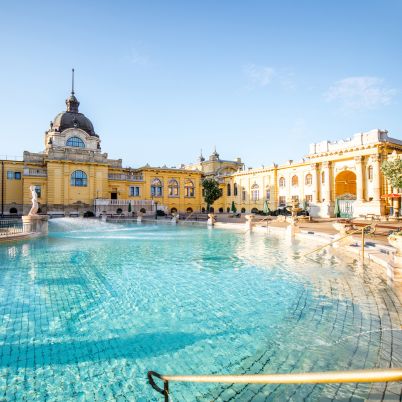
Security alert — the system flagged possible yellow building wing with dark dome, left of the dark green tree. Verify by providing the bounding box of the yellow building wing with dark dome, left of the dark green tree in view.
[0,91,203,216]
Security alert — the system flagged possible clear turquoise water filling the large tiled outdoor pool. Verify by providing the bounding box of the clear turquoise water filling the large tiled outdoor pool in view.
[0,219,402,401]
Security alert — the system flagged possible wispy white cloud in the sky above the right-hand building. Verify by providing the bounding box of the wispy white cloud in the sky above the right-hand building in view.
[325,77,396,110]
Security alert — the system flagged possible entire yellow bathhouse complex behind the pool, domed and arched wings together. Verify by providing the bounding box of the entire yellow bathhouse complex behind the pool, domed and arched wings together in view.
[0,83,402,217]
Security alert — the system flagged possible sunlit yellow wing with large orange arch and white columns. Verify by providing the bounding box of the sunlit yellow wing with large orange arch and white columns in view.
[224,129,402,217]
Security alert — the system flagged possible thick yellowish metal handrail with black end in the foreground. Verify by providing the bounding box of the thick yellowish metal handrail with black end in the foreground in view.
[148,368,402,401]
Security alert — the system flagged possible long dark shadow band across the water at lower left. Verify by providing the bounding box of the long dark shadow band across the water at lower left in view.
[0,332,207,368]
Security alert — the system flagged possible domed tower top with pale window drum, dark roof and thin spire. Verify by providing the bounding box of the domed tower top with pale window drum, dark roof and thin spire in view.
[45,69,101,152]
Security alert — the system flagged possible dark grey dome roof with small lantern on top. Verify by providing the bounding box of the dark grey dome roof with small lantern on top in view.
[51,88,99,137]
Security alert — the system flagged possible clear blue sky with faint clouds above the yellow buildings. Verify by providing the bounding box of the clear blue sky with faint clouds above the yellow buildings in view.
[0,0,402,167]
